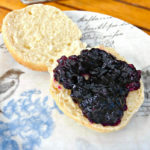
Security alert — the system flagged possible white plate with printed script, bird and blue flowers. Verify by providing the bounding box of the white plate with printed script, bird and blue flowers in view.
[0,11,150,150]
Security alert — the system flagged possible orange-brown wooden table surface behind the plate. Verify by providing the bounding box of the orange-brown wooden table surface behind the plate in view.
[0,0,150,35]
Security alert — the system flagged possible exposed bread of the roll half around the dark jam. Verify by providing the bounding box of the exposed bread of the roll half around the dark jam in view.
[49,47,144,132]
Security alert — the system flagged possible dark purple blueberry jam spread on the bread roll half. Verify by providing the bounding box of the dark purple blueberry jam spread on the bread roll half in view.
[54,48,141,126]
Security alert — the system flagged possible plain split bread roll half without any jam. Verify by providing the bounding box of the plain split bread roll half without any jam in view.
[2,4,85,71]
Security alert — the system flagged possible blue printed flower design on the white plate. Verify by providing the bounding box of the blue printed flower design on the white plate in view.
[0,89,63,150]
